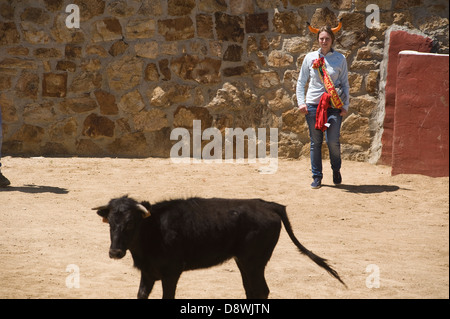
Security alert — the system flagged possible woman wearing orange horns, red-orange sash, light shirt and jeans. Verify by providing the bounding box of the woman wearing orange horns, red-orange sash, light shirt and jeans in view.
[296,23,350,189]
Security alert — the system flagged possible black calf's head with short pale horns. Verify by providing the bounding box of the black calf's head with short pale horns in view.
[93,196,150,259]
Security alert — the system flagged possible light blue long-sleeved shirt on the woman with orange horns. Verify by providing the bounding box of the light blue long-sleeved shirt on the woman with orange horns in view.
[296,49,350,110]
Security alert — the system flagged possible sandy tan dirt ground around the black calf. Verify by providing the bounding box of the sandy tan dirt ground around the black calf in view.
[0,157,449,299]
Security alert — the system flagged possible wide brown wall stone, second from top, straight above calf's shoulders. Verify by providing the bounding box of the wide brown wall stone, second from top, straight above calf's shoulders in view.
[158,17,195,41]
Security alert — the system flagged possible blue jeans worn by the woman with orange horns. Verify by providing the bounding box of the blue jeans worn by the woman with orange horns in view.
[306,104,342,179]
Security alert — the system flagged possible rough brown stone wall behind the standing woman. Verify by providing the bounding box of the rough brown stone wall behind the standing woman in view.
[0,0,449,161]
